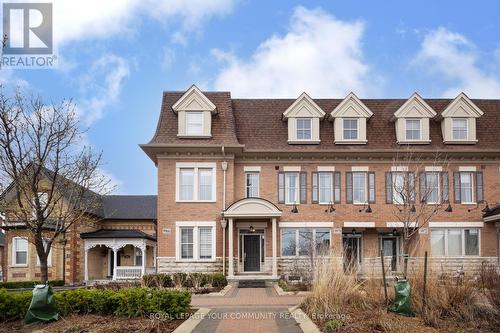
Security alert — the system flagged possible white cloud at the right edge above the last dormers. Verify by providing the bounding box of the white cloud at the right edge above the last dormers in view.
[414,27,500,98]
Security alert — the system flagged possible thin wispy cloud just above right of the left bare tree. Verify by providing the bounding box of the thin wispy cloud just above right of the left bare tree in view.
[77,54,130,125]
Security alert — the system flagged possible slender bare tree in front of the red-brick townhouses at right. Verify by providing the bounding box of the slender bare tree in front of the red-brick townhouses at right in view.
[386,147,449,278]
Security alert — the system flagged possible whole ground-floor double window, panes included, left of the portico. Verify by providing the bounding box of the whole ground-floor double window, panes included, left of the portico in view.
[176,221,215,261]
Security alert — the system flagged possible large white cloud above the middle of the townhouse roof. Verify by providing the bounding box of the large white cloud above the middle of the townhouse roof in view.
[212,7,380,97]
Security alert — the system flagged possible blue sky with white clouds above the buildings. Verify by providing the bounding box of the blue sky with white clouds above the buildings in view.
[0,0,500,194]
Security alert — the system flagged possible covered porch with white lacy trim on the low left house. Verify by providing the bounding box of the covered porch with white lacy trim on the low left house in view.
[81,229,156,283]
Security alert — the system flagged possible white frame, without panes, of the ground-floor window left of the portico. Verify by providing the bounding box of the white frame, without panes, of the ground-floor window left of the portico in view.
[175,221,217,262]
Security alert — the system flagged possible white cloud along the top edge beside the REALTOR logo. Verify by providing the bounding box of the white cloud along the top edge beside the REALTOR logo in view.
[53,0,236,44]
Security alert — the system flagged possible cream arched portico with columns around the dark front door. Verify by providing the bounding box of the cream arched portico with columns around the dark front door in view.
[223,198,282,279]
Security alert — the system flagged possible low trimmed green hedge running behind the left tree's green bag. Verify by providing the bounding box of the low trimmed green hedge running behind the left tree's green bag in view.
[0,288,191,322]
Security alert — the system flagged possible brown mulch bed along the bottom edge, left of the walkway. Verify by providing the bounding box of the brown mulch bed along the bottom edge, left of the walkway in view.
[0,315,183,333]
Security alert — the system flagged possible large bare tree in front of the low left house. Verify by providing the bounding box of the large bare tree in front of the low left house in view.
[0,89,109,282]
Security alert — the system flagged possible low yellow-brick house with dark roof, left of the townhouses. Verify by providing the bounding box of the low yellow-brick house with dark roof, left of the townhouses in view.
[0,176,157,284]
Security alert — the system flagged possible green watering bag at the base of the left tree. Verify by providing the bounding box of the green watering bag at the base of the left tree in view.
[24,284,58,325]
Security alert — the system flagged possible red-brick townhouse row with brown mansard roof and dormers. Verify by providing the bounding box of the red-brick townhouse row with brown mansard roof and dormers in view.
[141,86,500,278]
